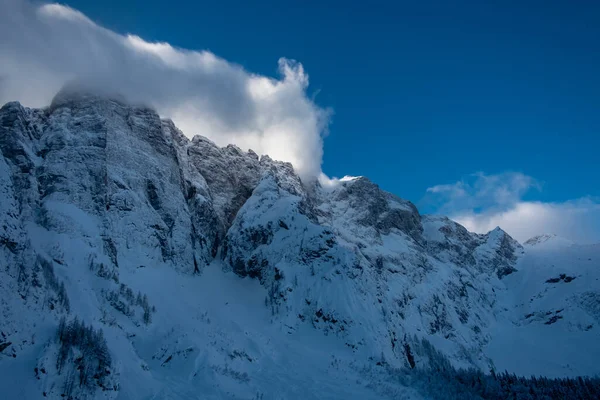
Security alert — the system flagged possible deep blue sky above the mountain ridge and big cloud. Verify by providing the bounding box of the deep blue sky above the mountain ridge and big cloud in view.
[0,0,600,240]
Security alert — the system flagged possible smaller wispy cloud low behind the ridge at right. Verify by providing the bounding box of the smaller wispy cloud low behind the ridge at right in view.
[425,173,600,243]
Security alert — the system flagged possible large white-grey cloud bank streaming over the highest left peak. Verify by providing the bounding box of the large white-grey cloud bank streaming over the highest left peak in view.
[0,0,330,179]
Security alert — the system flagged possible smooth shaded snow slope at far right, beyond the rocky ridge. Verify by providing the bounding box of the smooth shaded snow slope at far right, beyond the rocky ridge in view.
[487,235,600,377]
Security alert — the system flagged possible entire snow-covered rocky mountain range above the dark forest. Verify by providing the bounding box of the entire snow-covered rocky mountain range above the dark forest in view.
[0,90,600,399]
